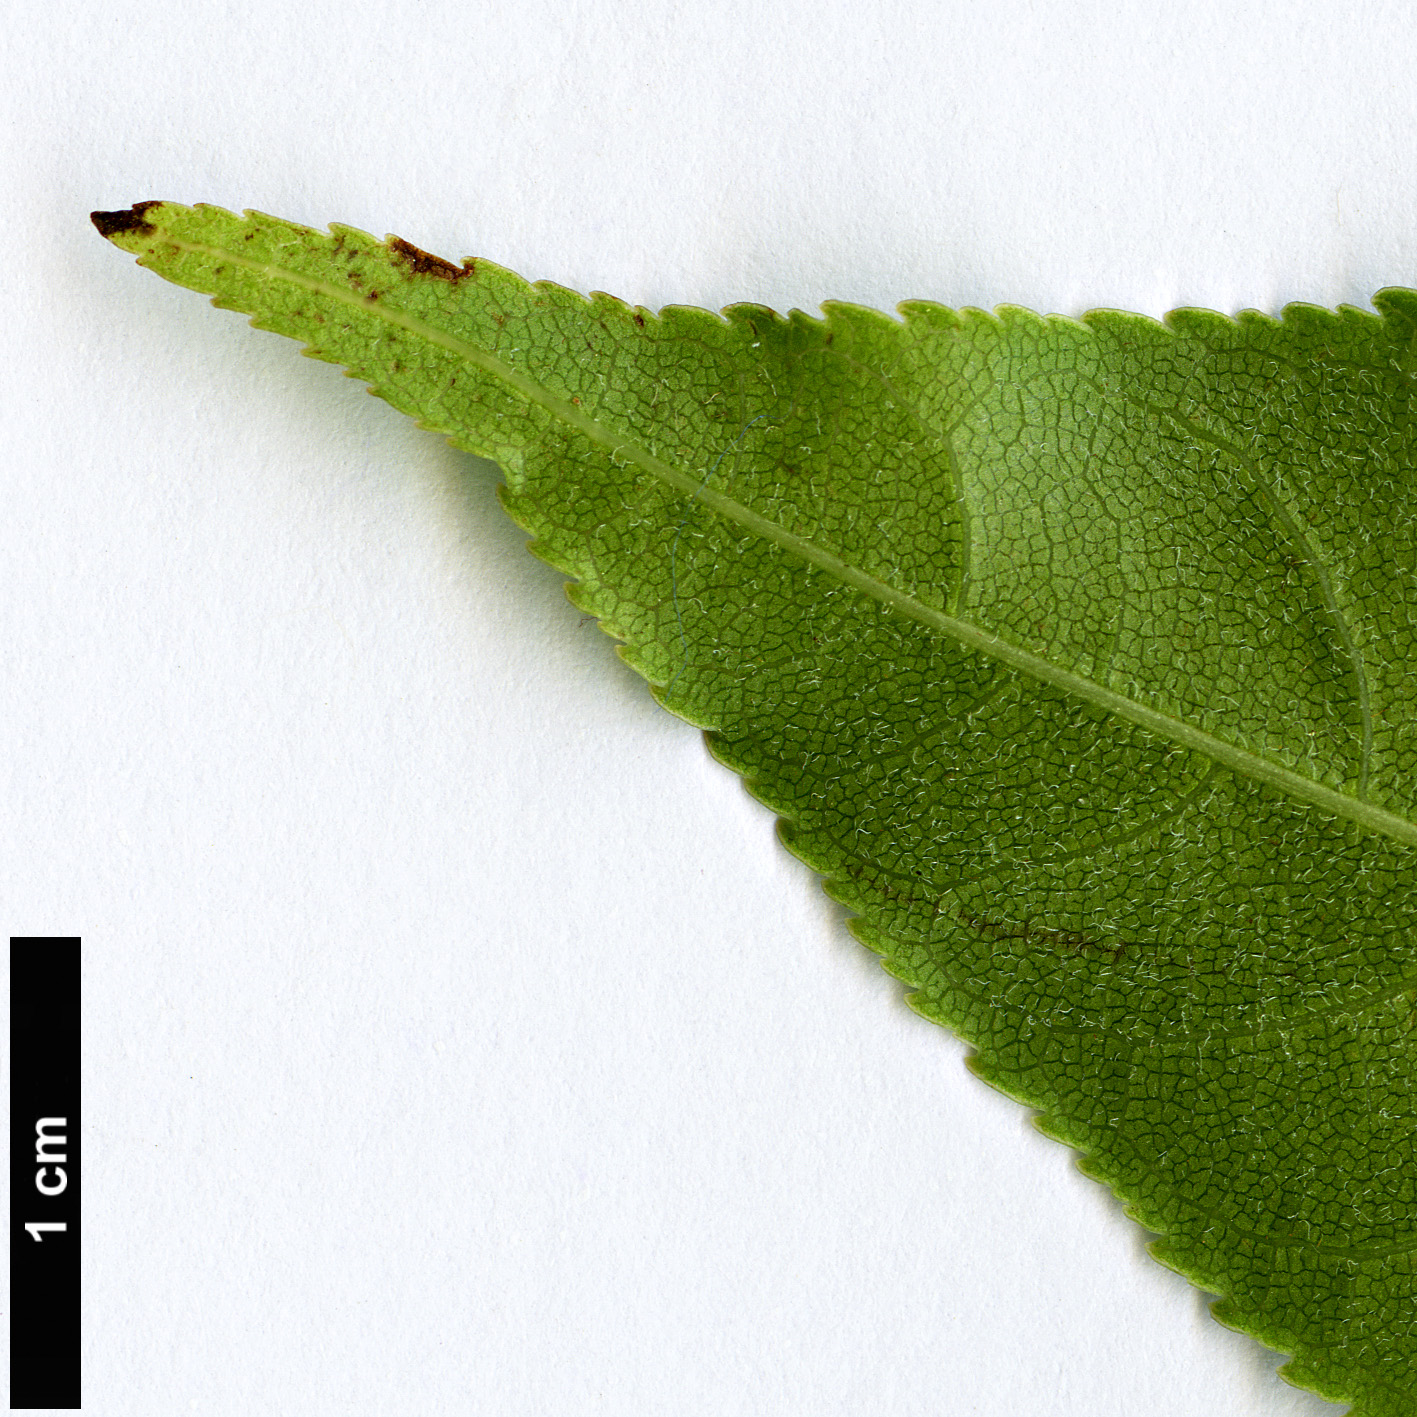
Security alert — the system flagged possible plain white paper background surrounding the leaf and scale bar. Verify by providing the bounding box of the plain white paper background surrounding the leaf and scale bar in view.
[0,0,1417,1417]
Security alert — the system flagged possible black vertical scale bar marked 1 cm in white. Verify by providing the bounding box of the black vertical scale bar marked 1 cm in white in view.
[10,935,82,1408]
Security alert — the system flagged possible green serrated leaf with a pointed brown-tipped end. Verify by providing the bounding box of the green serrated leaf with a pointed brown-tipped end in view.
[94,203,1417,1417]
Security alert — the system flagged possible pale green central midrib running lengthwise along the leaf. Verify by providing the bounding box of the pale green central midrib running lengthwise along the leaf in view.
[171,234,1417,846]
